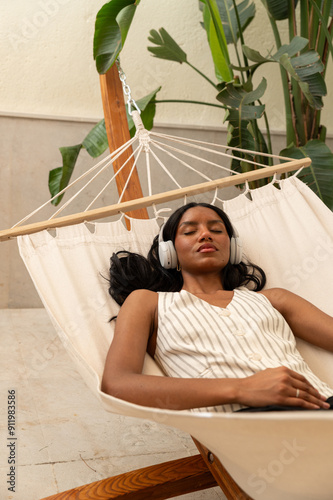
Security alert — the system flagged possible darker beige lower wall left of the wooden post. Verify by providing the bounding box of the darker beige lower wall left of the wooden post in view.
[0,117,112,308]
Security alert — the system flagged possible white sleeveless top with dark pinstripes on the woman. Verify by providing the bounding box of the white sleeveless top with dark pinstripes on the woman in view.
[155,288,333,412]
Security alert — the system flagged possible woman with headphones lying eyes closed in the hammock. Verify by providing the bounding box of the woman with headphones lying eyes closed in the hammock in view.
[102,203,333,411]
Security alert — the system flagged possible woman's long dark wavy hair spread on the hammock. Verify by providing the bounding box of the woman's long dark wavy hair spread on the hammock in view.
[109,202,266,305]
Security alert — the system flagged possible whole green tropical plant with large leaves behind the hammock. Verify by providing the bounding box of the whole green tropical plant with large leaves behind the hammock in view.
[50,0,333,209]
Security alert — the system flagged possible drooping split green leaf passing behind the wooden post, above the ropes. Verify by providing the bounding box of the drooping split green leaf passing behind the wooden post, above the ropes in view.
[49,87,161,206]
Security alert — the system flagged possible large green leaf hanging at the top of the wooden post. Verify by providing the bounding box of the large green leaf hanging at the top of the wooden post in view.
[94,0,140,74]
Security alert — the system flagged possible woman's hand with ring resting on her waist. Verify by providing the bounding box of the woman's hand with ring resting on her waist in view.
[236,366,330,410]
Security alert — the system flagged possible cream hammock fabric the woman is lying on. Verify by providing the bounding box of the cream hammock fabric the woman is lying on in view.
[18,176,333,500]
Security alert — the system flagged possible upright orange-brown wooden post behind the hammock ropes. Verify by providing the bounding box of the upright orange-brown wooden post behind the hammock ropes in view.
[100,64,148,219]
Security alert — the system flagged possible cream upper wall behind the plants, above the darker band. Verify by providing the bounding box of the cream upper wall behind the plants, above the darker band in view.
[0,0,333,132]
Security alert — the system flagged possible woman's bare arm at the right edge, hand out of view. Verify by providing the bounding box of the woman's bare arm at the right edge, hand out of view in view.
[260,288,333,352]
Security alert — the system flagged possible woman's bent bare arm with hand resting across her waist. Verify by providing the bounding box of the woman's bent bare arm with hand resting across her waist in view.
[102,290,327,410]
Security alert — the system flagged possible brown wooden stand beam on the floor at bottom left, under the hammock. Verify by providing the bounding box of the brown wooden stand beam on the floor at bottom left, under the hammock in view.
[42,455,217,500]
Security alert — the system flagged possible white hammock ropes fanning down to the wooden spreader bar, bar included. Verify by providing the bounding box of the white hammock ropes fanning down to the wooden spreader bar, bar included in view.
[0,110,311,241]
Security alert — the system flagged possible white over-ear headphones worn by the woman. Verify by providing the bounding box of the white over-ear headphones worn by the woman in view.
[158,224,243,269]
